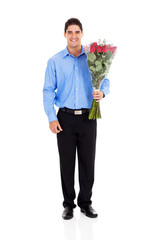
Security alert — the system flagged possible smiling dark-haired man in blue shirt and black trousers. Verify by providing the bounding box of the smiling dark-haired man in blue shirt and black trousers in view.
[43,18,109,219]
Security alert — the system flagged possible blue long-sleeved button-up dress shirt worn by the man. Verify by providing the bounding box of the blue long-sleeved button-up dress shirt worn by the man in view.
[43,46,110,122]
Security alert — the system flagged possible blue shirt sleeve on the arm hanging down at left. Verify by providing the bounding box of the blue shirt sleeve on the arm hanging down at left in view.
[43,60,58,122]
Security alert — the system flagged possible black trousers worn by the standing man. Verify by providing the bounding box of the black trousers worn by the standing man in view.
[57,109,97,208]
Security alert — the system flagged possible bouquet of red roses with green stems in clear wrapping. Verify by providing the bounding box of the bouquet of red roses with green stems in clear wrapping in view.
[84,40,117,119]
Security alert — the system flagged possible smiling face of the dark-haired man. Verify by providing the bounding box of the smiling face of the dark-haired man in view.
[64,25,83,48]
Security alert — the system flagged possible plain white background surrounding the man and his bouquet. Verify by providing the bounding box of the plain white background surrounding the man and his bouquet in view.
[0,0,160,240]
